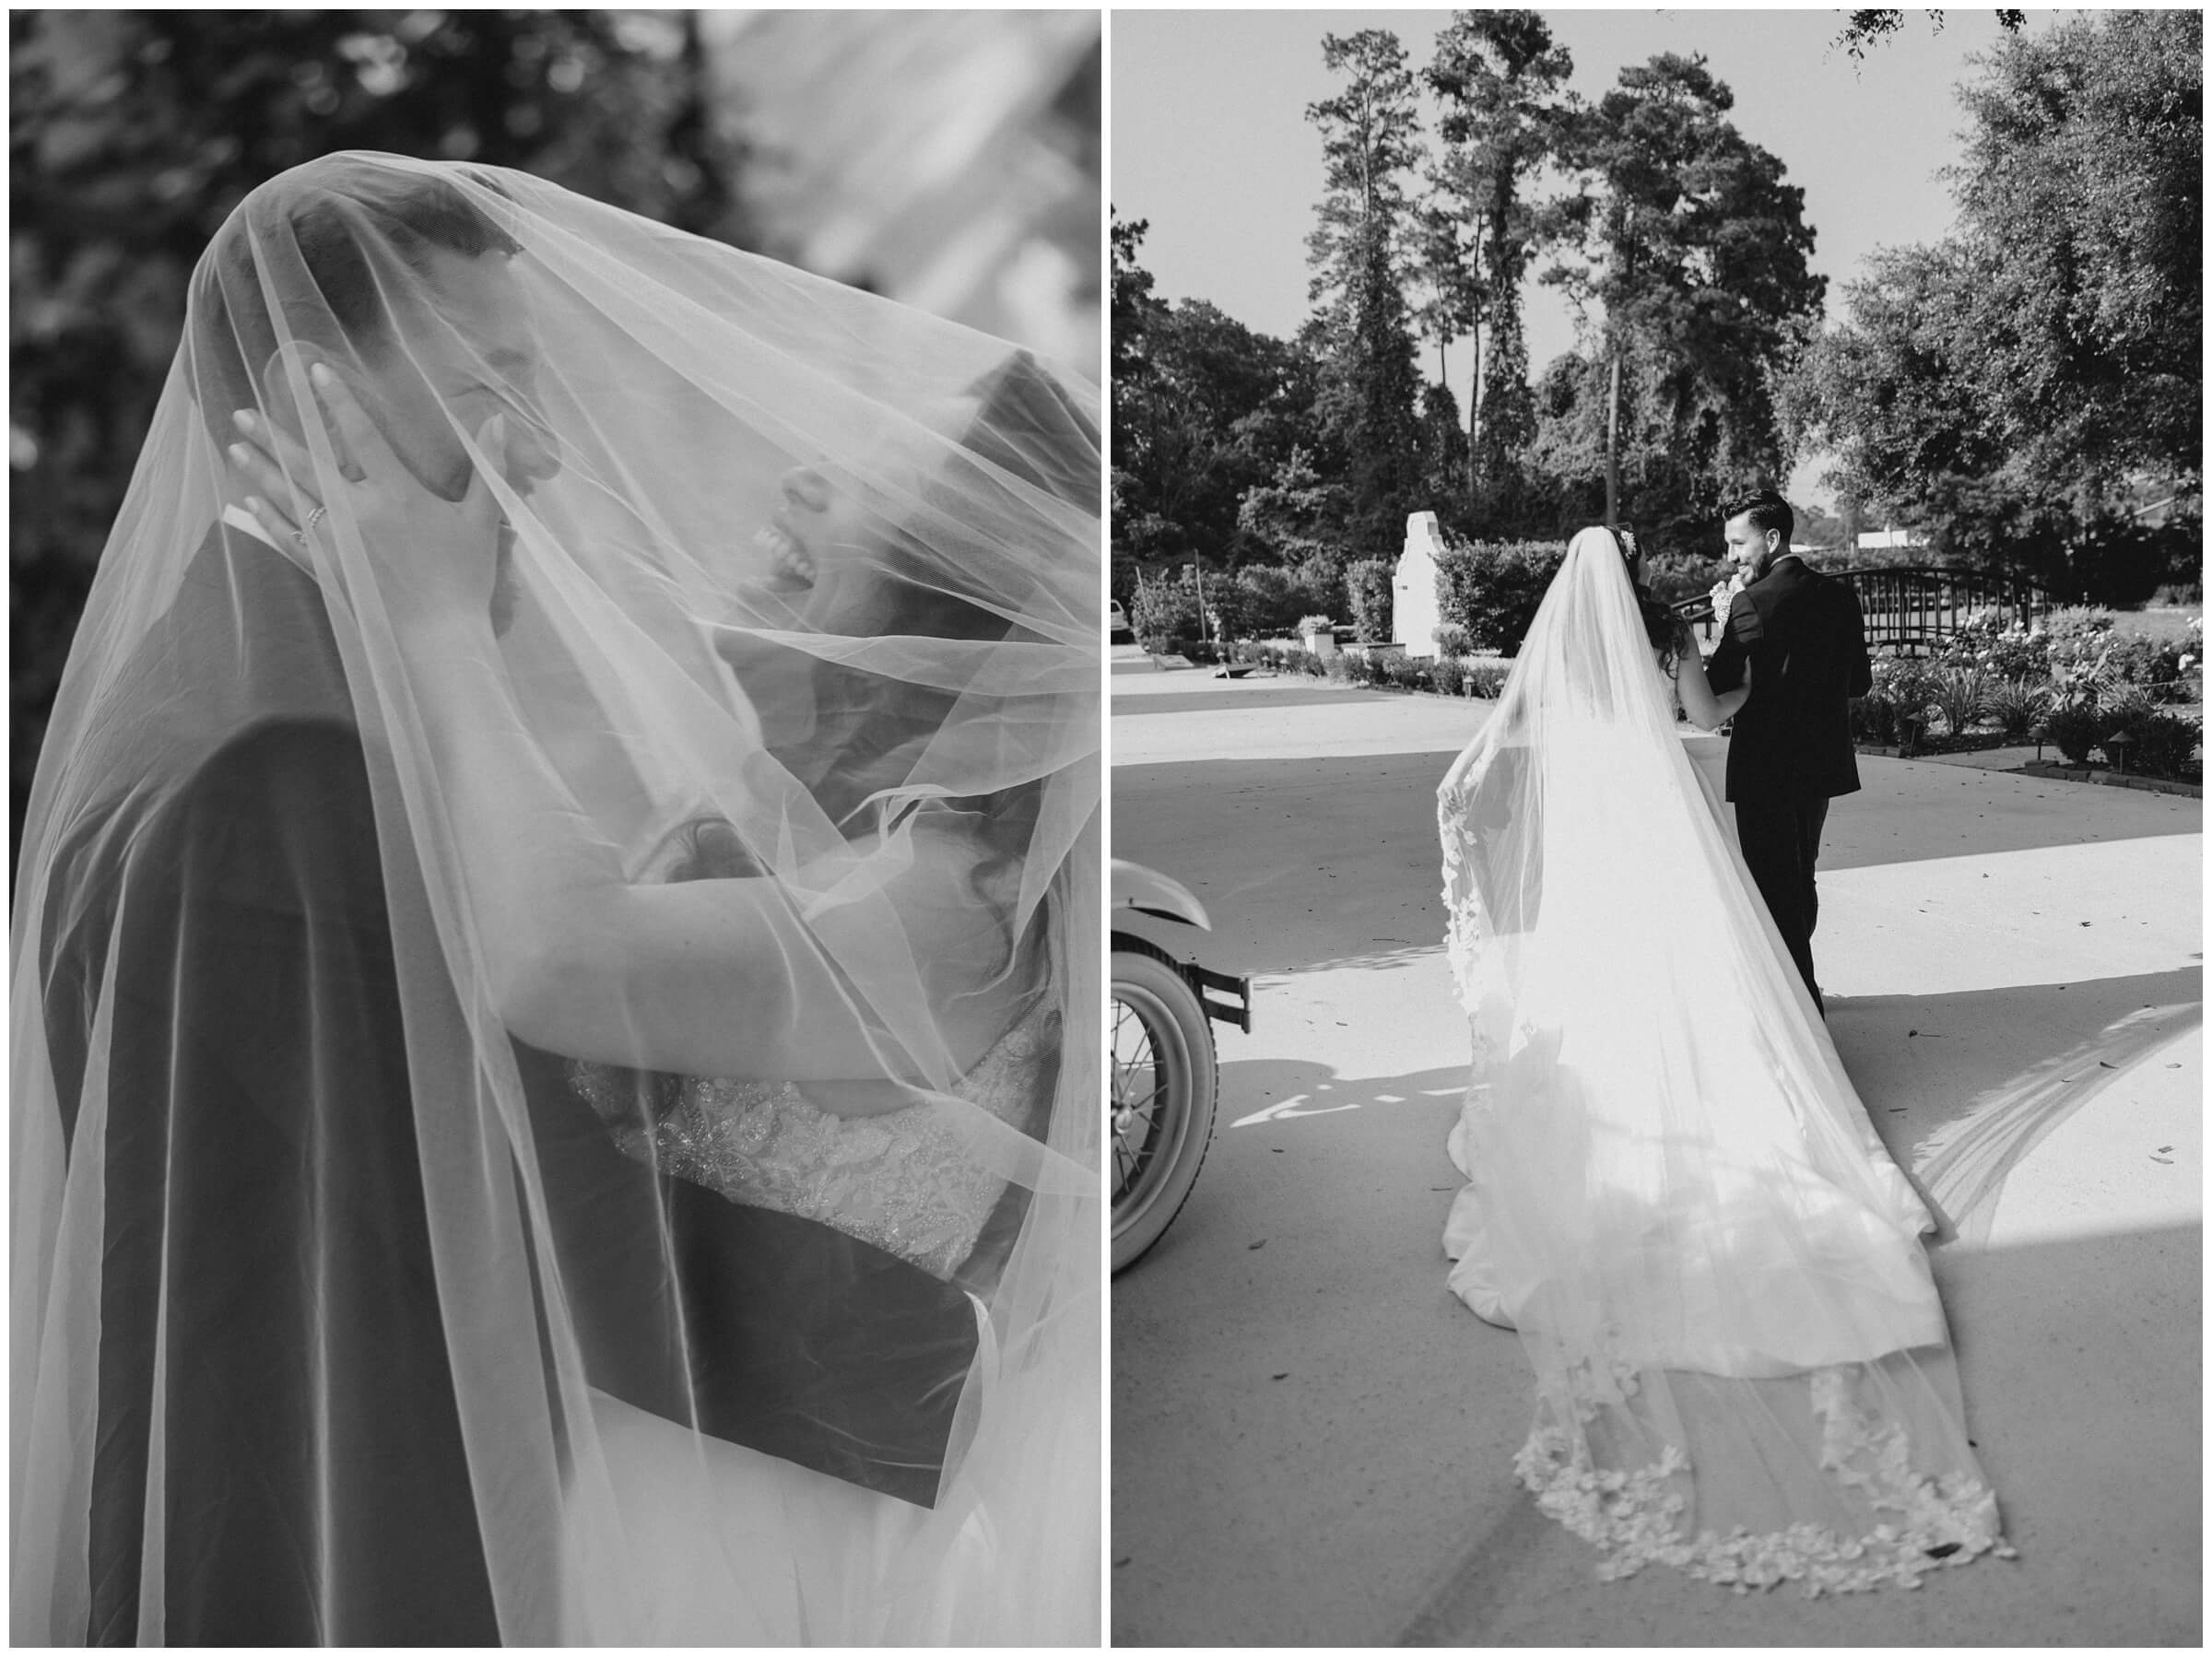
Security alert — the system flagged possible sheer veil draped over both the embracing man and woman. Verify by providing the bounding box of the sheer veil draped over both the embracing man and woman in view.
[11,155,1101,1644]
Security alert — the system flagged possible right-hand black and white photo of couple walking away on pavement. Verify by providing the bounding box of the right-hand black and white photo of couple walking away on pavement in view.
[1106,9,2203,1648]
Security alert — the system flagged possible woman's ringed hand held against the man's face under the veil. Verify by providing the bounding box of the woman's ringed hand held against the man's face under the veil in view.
[230,363,507,622]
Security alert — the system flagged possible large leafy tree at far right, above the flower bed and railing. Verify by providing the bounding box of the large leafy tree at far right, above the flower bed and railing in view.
[1783,11,2203,597]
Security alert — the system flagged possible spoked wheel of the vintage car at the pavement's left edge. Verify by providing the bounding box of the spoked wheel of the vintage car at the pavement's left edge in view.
[1106,938,1217,1272]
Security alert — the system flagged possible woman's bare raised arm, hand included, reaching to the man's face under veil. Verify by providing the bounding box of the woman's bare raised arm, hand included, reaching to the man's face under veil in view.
[237,376,1024,1084]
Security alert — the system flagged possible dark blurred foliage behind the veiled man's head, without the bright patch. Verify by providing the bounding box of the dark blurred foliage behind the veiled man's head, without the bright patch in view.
[9,11,754,828]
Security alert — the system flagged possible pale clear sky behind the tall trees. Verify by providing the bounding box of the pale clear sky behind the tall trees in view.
[1108,6,2070,504]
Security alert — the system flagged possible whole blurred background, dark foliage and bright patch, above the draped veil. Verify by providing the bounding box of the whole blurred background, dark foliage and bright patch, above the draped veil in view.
[9,11,1101,847]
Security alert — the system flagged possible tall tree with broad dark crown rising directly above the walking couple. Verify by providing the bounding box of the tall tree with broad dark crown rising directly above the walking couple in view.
[1547,53,1825,523]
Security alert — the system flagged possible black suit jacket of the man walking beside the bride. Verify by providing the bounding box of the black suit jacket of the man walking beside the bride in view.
[1705,556,1874,803]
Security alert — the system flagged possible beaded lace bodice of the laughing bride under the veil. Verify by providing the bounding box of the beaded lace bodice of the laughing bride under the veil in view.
[569,995,1060,1281]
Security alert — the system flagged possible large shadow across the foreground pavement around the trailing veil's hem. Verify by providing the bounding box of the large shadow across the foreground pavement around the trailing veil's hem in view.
[1112,1008,2203,1648]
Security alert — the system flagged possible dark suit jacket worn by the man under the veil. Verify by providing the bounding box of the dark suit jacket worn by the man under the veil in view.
[40,531,975,1644]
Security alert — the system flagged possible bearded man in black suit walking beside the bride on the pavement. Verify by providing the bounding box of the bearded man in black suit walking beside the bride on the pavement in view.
[1705,489,1874,1016]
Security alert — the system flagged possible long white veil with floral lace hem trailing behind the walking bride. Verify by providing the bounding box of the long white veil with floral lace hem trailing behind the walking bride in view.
[1438,529,2006,1592]
